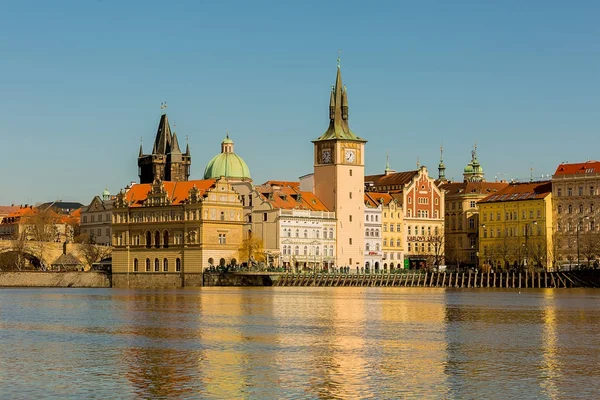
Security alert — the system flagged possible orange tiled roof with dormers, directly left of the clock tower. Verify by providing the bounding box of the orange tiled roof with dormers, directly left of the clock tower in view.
[255,181,329,211]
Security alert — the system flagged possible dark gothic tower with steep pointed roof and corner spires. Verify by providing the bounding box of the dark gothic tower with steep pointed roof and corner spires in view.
[138,114,192,183]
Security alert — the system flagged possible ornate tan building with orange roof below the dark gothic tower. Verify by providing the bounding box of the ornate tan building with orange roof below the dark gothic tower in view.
[112,179,243,287]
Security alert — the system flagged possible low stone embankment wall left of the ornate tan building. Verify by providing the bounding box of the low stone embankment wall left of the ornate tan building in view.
[0,271,110,288]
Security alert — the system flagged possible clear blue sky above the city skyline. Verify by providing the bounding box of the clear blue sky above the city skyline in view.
[0,0,600,204]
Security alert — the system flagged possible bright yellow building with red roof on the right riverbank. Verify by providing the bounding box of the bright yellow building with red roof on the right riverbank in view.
[477,181,554,271]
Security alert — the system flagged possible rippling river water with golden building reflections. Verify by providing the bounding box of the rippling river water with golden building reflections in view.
[0,287,600,399]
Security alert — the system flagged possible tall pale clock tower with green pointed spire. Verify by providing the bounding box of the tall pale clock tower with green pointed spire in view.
[313,58,367,267]
